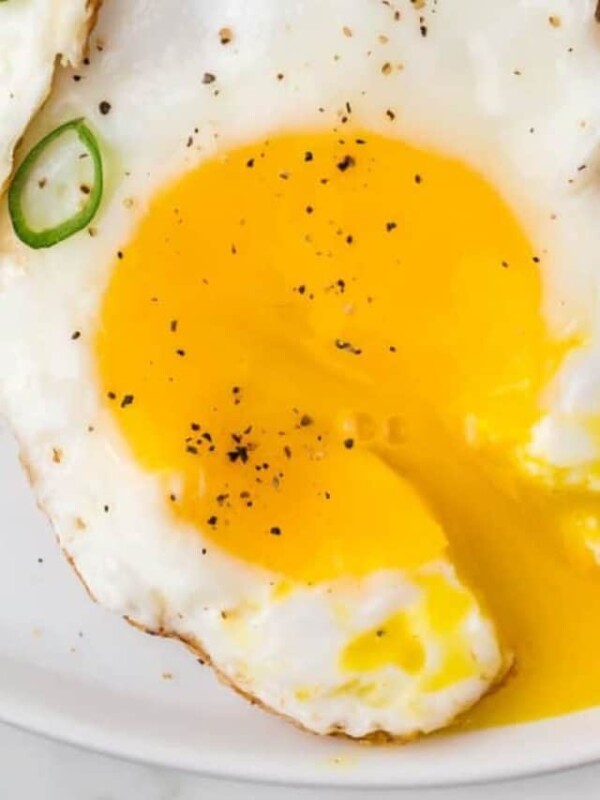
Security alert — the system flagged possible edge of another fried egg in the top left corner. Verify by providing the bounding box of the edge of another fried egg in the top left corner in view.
[0,0,99,188]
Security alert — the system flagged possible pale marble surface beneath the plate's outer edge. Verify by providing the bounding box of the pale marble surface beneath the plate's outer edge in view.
[0,725,600,800]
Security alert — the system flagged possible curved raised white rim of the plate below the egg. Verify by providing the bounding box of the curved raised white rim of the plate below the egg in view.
[0,687,600,790]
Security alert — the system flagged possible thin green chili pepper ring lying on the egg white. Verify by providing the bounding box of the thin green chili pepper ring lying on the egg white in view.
[7,117,104,250]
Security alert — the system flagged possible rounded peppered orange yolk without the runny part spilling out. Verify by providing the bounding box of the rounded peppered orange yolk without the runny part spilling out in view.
[99,135,544,581]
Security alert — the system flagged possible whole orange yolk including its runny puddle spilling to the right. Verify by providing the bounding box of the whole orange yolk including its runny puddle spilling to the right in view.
[96,132,600,726]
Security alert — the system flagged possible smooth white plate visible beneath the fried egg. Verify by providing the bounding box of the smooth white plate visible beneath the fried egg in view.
[0,422,600,787]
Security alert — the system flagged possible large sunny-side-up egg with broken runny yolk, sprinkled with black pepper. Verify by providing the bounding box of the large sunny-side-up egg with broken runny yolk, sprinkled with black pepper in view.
[0,0,600,738]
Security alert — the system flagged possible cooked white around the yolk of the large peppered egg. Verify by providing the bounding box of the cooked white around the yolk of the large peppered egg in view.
[0,0,600,737]
